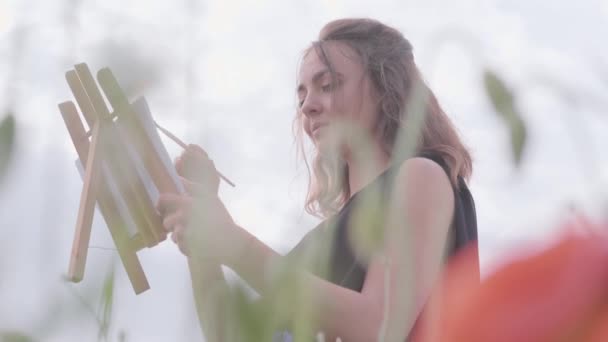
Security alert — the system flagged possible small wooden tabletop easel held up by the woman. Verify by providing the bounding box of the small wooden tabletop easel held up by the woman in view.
[59,64,183,294]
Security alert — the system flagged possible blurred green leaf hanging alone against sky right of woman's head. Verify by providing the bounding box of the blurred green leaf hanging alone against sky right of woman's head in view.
[483,69,528,166]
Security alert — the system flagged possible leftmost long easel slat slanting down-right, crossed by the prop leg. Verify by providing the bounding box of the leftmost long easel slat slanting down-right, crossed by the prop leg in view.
[59,101,150,294]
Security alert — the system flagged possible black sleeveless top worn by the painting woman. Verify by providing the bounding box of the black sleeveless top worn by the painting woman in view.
[287,153,479,292]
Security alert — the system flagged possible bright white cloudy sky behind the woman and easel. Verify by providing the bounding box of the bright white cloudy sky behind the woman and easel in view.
[0,0,608,341]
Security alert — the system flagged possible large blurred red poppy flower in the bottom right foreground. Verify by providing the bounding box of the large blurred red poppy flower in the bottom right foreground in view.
[413,221,608,342]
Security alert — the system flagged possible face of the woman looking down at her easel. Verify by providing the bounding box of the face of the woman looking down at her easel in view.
[297,42,377,152]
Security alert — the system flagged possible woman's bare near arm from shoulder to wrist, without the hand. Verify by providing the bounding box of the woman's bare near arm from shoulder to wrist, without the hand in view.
[221,158,454,341]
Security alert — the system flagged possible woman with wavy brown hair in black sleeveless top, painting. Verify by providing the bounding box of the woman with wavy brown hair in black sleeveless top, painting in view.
[158,19,477,341]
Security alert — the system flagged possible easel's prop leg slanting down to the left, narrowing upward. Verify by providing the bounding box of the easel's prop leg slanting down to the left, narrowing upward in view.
[68,123,101,282]
